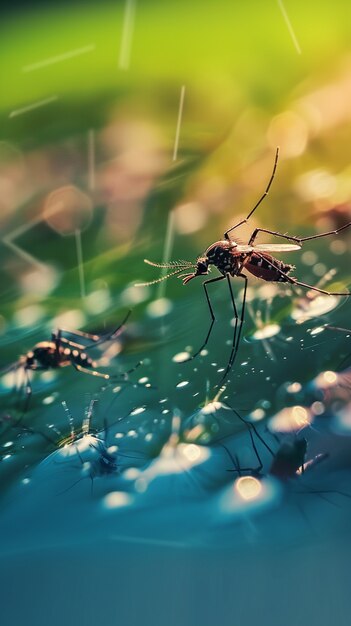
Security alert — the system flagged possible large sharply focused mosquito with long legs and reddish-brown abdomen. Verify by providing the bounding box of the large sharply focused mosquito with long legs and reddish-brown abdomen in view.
[138,148,351,383]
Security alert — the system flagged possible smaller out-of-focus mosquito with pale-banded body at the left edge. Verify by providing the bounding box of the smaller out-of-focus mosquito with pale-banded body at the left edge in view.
[0,311,133,411]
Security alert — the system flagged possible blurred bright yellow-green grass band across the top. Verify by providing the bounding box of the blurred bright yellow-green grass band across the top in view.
[0,0,351,136]
